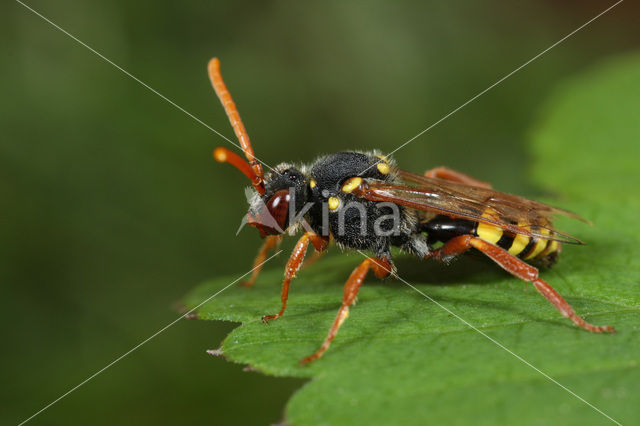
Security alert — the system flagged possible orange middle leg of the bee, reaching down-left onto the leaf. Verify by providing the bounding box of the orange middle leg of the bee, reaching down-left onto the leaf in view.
[300,258,393,364]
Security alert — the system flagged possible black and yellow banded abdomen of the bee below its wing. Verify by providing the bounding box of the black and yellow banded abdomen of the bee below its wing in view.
[421,215,560,261]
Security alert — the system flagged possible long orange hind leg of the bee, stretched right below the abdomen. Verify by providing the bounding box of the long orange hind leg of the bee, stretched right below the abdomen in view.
[434,235,615,333]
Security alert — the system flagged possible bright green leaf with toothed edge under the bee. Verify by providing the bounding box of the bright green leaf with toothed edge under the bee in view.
[182,56,640,425]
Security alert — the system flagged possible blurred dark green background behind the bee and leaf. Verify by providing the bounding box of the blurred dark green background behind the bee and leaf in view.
[0,0,640,424]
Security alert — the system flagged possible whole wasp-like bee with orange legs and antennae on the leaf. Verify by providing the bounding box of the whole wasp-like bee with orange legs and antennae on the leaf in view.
[208,58,614,364]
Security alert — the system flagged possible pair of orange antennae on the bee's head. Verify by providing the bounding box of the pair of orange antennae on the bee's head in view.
[207,58,265,195]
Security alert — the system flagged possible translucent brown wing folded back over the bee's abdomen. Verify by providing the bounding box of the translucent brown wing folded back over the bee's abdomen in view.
[354,170,586,244]
